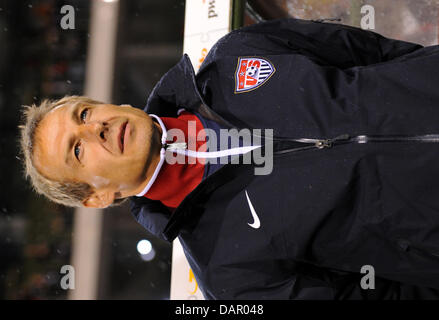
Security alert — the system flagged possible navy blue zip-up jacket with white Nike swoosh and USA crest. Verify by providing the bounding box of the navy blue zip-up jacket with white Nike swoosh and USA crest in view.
[131,19,439,299]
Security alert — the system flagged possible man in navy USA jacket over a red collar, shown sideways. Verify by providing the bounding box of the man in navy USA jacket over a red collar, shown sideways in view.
[22,19,439,299]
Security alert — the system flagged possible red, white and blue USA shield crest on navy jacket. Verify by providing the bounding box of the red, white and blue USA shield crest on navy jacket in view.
[235,57,276,93]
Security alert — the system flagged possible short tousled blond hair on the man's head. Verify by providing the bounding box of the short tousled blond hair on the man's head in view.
[19,96,125,207]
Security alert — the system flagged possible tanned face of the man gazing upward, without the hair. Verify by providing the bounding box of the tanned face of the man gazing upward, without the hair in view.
[34,104,161,206]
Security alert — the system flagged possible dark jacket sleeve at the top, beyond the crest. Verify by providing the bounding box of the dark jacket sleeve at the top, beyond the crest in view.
[211,18,423,69]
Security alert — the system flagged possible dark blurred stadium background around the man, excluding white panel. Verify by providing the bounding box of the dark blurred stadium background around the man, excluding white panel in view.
[0,0,439,299]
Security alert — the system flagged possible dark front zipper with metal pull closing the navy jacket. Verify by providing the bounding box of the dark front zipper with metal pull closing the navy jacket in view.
[274,134,439,154]
